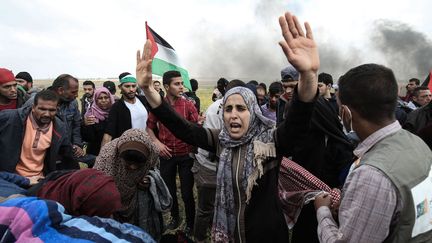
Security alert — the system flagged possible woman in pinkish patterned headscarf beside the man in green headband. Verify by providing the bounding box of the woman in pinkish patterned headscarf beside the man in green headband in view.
[81,87,115,155]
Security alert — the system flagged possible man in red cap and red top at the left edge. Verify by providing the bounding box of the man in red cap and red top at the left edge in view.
[0,68,28,111]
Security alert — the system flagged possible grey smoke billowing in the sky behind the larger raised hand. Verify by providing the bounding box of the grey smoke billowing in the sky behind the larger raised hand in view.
[187,0,432,83]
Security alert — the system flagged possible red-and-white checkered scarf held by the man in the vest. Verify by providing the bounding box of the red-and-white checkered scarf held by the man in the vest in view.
[279,158,340,229]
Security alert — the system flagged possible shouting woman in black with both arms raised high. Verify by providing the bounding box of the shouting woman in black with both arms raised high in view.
[136,14,319,242]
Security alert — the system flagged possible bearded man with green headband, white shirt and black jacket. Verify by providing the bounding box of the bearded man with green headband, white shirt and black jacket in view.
[101,74,148,147]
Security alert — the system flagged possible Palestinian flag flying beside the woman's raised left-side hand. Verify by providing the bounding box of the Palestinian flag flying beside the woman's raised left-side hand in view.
[146,22,192,90]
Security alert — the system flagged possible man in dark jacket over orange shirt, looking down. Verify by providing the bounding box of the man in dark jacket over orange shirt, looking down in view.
[0,90,79,178]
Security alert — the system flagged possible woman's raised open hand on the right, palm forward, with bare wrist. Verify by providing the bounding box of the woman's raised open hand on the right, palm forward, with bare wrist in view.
[279,12,320,102]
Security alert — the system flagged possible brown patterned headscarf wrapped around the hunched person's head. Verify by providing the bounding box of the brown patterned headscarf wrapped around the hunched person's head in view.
[94,129,159,224]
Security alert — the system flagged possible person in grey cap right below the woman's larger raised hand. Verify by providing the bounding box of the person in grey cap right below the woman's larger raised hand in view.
[276,65,299,124]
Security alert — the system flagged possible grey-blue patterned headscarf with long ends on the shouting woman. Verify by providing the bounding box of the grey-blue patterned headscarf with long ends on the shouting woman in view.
[212,87,275,242]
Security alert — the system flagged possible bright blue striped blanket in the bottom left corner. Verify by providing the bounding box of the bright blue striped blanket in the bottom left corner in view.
[0,197,155,242]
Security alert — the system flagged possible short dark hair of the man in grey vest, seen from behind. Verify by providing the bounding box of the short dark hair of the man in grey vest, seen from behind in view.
[339,64,398,125]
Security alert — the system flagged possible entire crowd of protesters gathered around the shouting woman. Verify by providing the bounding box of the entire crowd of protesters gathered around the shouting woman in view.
[0,10,432,242]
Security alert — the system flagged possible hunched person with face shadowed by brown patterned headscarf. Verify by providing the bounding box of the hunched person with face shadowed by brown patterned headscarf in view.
[94,129,172,239]
